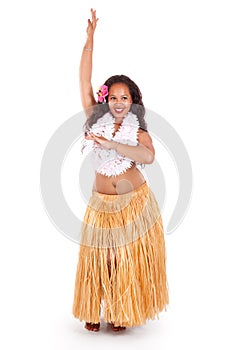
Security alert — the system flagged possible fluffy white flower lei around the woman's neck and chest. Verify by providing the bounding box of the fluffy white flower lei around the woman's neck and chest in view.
[82,112,139,176]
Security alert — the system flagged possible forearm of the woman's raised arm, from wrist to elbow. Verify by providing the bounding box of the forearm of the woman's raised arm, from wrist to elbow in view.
[79,35,94,83]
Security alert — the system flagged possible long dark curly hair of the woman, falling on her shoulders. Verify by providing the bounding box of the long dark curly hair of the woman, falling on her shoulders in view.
[84,74,147,132]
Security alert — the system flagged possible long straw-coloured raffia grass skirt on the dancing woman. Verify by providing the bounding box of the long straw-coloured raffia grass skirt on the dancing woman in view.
[72,182,169,327]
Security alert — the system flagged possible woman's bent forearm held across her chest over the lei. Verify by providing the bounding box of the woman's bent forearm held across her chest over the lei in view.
[111,141,154,164]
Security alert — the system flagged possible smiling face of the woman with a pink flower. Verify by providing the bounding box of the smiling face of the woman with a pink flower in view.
[108,83,133,119]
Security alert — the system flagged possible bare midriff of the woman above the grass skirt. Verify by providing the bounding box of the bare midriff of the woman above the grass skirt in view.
[93,163,145,194]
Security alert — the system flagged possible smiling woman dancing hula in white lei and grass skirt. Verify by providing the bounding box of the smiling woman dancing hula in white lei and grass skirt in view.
[73,9,169,331]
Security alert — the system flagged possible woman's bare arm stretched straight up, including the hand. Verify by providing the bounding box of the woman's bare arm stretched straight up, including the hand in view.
[79,9,98,116]
